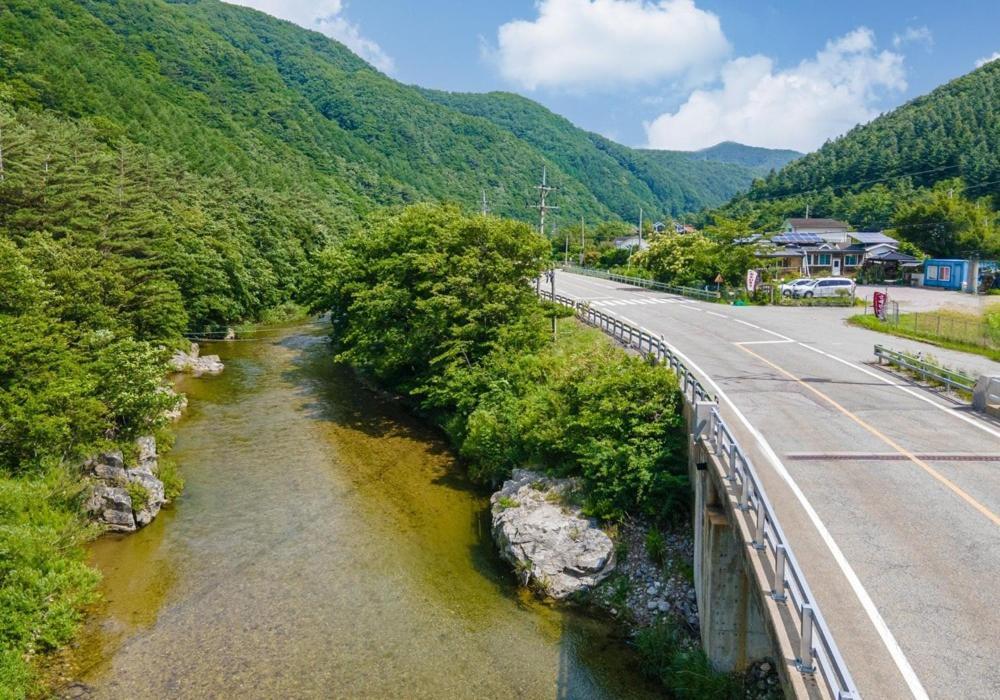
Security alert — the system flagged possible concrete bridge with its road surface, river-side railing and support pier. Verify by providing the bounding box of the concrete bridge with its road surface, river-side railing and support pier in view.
[553,271,1000,700]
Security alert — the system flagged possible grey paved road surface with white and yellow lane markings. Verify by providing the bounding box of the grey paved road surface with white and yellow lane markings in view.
[556,272,1000,700]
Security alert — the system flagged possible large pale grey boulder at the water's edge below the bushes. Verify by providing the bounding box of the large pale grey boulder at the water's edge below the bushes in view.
[490,470,615,600]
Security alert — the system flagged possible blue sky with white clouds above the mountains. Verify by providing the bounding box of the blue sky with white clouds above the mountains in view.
[228,0,1000,152]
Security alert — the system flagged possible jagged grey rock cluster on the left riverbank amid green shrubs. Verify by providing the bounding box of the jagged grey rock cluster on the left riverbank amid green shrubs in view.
[85,436,166,532]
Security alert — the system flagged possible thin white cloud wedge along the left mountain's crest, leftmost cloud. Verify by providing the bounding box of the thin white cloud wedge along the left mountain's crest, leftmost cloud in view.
[226,0,395,73]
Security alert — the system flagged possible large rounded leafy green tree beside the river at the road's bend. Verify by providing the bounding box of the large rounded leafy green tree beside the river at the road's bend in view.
[312,205,549,390]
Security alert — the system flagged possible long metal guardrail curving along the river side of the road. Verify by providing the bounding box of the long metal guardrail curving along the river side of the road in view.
[539,290,861,700]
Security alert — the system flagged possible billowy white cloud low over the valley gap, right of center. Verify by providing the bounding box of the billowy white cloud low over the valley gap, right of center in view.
[646,27,906,151]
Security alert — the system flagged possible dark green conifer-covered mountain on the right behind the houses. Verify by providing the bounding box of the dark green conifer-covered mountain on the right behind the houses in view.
[712,61,1000,259]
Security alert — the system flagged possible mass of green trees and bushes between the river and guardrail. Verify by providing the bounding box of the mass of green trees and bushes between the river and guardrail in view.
[313,205,688,518]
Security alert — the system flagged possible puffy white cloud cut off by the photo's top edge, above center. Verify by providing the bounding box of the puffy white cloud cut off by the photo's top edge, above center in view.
[491,0,729,90]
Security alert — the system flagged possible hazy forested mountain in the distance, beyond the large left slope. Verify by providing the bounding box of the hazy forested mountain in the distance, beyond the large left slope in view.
[422,90,784,219]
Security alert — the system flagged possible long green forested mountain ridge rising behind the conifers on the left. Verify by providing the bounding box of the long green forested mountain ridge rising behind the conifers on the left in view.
[0,0,796,227]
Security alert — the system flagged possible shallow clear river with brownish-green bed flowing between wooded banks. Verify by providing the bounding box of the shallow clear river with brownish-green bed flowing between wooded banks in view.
[73,331,655,699]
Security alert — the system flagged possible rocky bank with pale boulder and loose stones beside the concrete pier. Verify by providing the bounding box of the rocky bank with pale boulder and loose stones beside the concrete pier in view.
[490,470,784,700]
